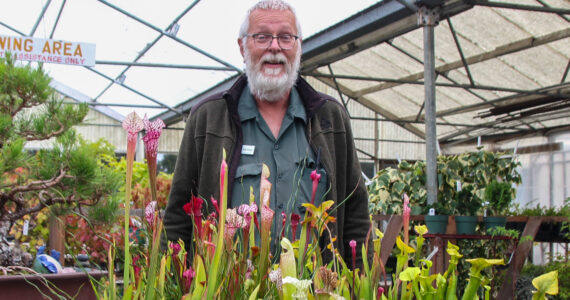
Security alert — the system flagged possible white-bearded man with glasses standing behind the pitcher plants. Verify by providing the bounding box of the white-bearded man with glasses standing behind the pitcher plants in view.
[164,0,370,264]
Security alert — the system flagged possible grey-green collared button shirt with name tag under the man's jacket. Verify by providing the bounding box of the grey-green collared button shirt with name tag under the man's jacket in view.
[231,87,327,246]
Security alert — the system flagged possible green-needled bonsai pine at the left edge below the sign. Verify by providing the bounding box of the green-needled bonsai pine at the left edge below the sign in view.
[0,53,117,266]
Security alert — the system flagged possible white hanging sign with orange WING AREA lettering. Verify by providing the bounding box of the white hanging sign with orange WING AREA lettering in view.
[0,35,95,67]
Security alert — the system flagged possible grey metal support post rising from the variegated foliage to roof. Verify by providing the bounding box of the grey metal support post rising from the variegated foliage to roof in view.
[418,7,440,204]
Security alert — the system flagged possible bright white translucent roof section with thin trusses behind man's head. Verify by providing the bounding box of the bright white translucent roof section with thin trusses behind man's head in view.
[0,0,376,117]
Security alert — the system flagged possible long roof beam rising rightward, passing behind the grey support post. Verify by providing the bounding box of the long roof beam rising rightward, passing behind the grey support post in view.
[355,28,570,96]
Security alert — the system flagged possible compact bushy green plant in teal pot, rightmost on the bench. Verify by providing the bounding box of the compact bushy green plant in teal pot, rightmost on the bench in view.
[484,180,515,230]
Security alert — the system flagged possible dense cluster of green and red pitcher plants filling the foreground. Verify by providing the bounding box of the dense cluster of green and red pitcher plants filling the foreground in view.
[94,144,557,300]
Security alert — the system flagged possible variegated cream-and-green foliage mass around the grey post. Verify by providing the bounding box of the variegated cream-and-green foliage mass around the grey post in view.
[368,148,521,215]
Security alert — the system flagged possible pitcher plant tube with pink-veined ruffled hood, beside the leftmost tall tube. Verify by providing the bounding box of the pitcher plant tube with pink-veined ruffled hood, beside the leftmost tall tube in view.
[143,116,166,207]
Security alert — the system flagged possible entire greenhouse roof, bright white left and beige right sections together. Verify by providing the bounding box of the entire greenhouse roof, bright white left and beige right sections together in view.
[0,0,570,158]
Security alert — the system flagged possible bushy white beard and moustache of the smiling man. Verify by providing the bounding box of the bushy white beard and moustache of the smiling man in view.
[244,47,301,102]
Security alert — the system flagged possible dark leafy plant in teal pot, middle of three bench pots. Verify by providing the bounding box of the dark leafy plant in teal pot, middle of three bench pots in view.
[452,185,483,234]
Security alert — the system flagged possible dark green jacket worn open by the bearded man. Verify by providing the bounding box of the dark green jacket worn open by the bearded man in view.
[164,75,372,265]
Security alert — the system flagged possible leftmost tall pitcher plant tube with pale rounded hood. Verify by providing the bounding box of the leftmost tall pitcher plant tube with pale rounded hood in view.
[123,112,144,288]
